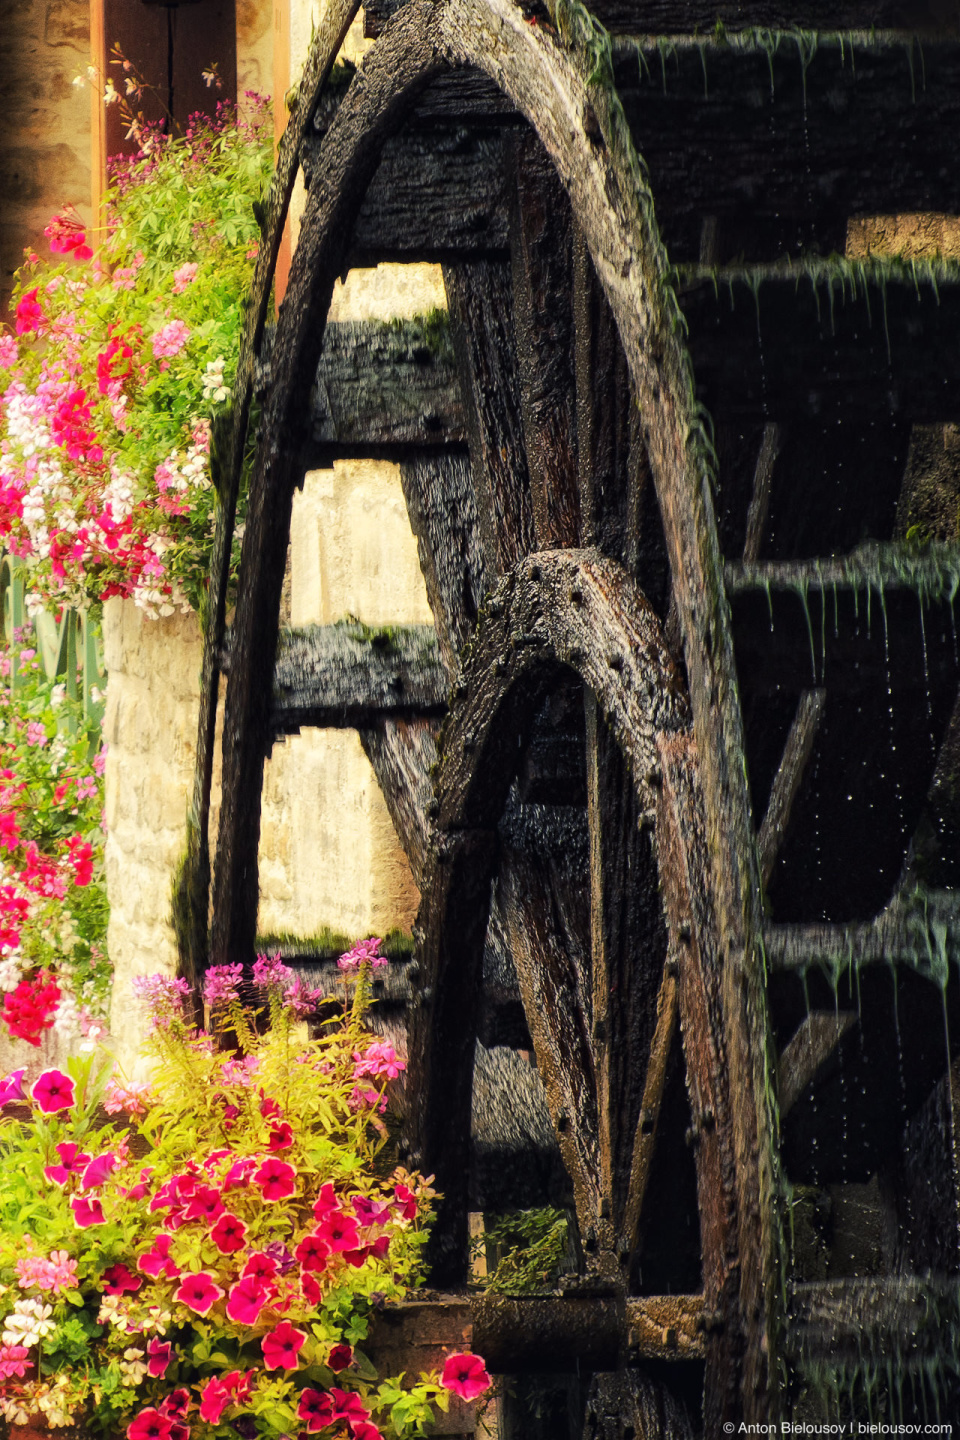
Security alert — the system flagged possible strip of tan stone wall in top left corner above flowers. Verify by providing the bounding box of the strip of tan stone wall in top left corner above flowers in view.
[0,0,91,320]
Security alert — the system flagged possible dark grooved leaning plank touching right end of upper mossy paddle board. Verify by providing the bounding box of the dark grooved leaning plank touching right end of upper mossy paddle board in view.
[443,261,535,576]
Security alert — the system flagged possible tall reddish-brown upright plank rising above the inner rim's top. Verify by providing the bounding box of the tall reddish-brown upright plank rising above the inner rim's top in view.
[508,132,580,550]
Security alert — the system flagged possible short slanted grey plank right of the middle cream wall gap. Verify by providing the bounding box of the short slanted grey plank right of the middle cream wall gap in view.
[400,454,486,677]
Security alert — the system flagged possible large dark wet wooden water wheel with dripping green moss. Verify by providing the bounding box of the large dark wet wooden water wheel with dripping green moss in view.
[185,0,960,1437]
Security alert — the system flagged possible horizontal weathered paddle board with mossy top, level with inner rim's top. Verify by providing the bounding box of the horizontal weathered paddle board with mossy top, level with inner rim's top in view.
[259,622,448,734]
